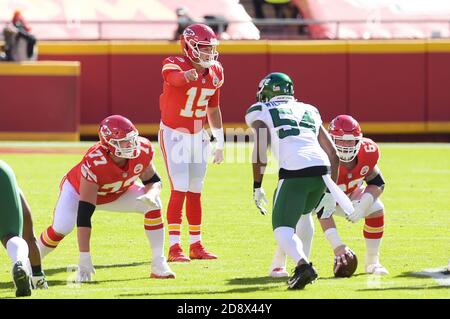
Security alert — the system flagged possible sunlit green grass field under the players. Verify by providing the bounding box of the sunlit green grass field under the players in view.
[0,143,450,299]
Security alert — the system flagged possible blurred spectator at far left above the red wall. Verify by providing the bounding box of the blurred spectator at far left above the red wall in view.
[2,11,37,61]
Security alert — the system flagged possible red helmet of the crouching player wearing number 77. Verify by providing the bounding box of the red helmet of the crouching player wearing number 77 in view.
[98,115,141,158]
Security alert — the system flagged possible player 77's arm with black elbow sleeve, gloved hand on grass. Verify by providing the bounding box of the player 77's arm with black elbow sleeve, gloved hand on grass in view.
[77,177,98,282]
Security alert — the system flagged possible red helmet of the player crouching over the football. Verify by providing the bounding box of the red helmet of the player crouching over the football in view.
[328,115,363,162]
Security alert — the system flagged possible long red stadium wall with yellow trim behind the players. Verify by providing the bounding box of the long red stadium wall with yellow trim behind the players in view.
[29,41,450,138]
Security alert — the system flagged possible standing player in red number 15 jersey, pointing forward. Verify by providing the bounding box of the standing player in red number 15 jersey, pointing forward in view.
[158,24,224,262]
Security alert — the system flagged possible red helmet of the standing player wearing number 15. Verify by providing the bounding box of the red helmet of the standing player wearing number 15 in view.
[180,23,219,68]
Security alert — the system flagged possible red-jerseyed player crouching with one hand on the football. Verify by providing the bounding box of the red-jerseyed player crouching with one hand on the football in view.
[270,115,388,277]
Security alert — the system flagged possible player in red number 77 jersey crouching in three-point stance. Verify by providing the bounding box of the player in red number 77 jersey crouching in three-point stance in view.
[39,115,175,282]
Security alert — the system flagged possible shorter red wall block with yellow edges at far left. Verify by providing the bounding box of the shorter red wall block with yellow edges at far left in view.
[0,62,80,140]
